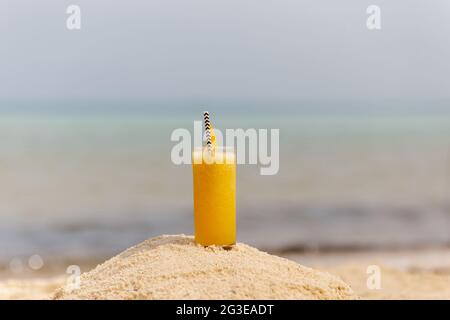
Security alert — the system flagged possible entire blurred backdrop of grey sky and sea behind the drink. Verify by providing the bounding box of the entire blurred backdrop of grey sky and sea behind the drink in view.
[0,0,450,273]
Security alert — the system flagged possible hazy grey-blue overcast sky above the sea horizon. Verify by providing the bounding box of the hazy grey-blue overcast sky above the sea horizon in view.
[0,0,450,105]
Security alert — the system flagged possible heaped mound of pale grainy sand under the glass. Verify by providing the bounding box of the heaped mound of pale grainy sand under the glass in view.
[52,235,356,299]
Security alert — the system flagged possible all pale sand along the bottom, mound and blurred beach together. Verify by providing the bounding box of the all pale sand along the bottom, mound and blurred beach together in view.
[0,236,450,299]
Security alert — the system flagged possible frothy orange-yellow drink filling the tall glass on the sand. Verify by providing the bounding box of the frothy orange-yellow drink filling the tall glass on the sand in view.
[192,148,236,246]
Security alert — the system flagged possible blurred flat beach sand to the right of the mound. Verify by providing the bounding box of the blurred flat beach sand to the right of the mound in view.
[286,249,450,300]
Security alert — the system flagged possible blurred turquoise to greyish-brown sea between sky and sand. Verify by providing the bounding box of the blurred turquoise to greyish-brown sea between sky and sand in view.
[0,107,450,263]
